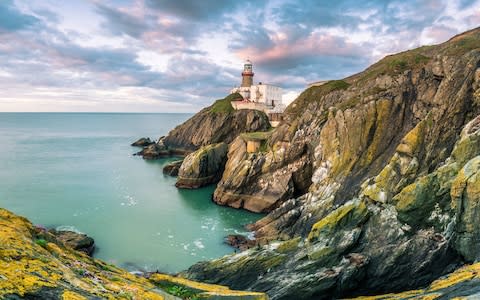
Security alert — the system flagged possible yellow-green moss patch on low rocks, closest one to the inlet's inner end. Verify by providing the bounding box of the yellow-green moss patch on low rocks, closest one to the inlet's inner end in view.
[308,201,368,241]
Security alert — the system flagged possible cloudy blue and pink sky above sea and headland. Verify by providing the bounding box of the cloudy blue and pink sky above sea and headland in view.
[0,0,480,112]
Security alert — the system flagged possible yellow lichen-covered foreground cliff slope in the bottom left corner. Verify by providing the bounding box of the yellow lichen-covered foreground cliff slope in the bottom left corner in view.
[0,209,267,300]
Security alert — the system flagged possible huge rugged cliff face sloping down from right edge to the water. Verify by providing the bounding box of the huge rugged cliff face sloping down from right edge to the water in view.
[184,29,480,299]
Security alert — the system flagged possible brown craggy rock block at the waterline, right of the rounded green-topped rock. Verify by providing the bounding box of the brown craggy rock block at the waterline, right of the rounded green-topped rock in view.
[214,137,311,212]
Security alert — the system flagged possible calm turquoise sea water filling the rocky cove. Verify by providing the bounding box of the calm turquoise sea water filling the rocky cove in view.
[0,113,260,272]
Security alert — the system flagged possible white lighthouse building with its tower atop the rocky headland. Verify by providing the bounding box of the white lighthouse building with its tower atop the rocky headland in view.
[230,60,285,114]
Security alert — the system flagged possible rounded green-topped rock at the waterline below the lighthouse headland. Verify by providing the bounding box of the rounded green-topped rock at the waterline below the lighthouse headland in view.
[175,143,228,189]
